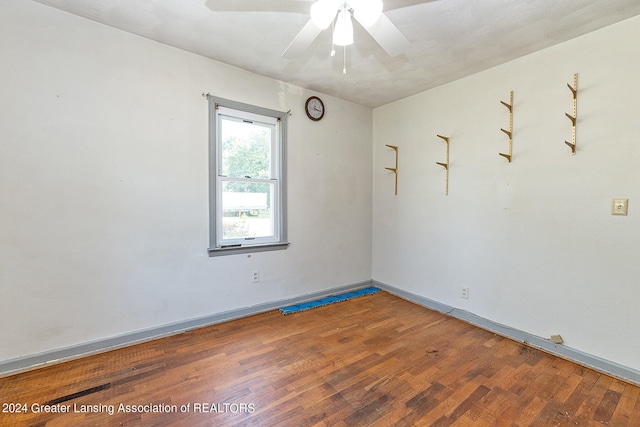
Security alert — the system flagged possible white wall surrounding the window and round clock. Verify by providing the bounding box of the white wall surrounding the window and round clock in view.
[0,0,372,361]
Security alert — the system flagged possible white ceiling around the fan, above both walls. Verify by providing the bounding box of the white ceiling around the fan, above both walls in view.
[36,0,640,107]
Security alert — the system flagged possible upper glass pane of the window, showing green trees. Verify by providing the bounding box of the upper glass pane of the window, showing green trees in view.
[220,117,273,179]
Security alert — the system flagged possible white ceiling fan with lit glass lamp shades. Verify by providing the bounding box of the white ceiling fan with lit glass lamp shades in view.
[207,0,433,59]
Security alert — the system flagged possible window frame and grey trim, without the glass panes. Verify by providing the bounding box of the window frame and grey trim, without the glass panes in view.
[207,95,289,256]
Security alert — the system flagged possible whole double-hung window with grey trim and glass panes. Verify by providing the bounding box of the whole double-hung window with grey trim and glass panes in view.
[208,95,288,256]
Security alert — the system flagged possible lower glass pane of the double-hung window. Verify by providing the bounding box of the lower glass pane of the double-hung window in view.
[222,181,275,240]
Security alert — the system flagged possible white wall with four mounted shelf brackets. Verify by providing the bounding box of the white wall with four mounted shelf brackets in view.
[373,18,640,370]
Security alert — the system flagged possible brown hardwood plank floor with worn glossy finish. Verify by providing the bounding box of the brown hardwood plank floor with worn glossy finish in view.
[0,292,640,427]
